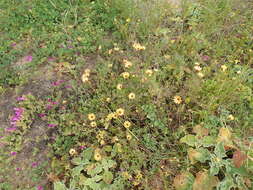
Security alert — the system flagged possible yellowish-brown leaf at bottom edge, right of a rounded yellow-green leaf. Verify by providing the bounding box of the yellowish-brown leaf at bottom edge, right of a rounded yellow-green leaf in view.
[193,171,219,190]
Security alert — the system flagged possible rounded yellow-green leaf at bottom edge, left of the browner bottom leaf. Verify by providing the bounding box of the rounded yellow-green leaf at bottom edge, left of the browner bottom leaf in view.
[173,172,194,190]
